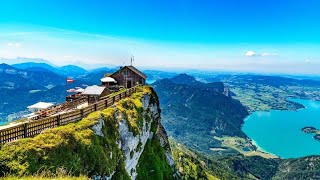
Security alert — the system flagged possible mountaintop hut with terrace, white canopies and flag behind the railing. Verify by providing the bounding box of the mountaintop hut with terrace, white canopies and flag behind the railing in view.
[2,65,147,125]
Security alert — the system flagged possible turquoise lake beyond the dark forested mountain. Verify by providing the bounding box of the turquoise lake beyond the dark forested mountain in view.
[242,99,320,158]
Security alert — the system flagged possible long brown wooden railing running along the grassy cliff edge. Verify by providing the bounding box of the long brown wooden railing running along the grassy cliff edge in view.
[0,85,141,144]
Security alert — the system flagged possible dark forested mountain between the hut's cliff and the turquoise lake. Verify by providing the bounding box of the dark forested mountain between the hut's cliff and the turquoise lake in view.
[153,74,248,153]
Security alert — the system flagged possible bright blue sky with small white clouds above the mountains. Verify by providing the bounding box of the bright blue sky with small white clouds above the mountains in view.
[0,0,320,74]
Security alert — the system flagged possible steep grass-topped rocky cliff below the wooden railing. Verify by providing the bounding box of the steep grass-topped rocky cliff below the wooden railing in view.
[0,87,174,179]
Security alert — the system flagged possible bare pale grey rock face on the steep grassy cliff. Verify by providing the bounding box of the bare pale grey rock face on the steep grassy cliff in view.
[119,90,174,179]
